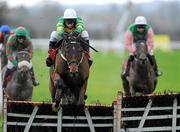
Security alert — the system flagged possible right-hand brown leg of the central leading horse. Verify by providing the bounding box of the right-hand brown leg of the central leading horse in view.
[77,81,87,105]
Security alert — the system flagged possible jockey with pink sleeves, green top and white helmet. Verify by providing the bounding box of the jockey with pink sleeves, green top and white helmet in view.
[122,16,161,76]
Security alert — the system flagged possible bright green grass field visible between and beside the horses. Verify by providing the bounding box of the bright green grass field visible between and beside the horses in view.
[33,50,180,104]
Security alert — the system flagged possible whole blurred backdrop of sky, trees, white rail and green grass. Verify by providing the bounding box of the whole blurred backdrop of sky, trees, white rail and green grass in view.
[0,0,180,103]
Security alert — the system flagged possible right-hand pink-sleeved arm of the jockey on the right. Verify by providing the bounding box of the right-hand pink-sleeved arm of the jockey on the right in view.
[147,28,154,53]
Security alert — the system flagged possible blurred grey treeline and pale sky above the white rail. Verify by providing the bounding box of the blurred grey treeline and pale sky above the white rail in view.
[0,0,180,41]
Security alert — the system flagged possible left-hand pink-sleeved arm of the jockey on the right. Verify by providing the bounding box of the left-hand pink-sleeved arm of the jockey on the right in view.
[125,30,136,53]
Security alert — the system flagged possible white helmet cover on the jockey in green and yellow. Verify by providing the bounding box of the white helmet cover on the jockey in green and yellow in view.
[63,9,77,19]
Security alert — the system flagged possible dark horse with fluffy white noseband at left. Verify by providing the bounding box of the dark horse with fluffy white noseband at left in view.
[2,51,33,101]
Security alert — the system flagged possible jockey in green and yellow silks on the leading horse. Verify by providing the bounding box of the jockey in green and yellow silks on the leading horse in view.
[46,9,93,67]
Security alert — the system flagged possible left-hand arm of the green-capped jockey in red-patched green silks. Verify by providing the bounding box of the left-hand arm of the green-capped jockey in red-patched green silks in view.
[6,37,17,66]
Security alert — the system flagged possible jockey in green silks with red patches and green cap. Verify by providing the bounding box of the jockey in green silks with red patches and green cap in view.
[3,26,39,87]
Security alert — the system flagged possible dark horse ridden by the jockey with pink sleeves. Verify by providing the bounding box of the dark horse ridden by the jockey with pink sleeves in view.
[121,40,157,95]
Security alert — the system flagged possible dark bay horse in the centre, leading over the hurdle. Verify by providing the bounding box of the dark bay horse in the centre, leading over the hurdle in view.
[49,34,89,111]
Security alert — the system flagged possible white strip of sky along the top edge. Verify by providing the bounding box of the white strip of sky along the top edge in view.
[4,0,158,7]
